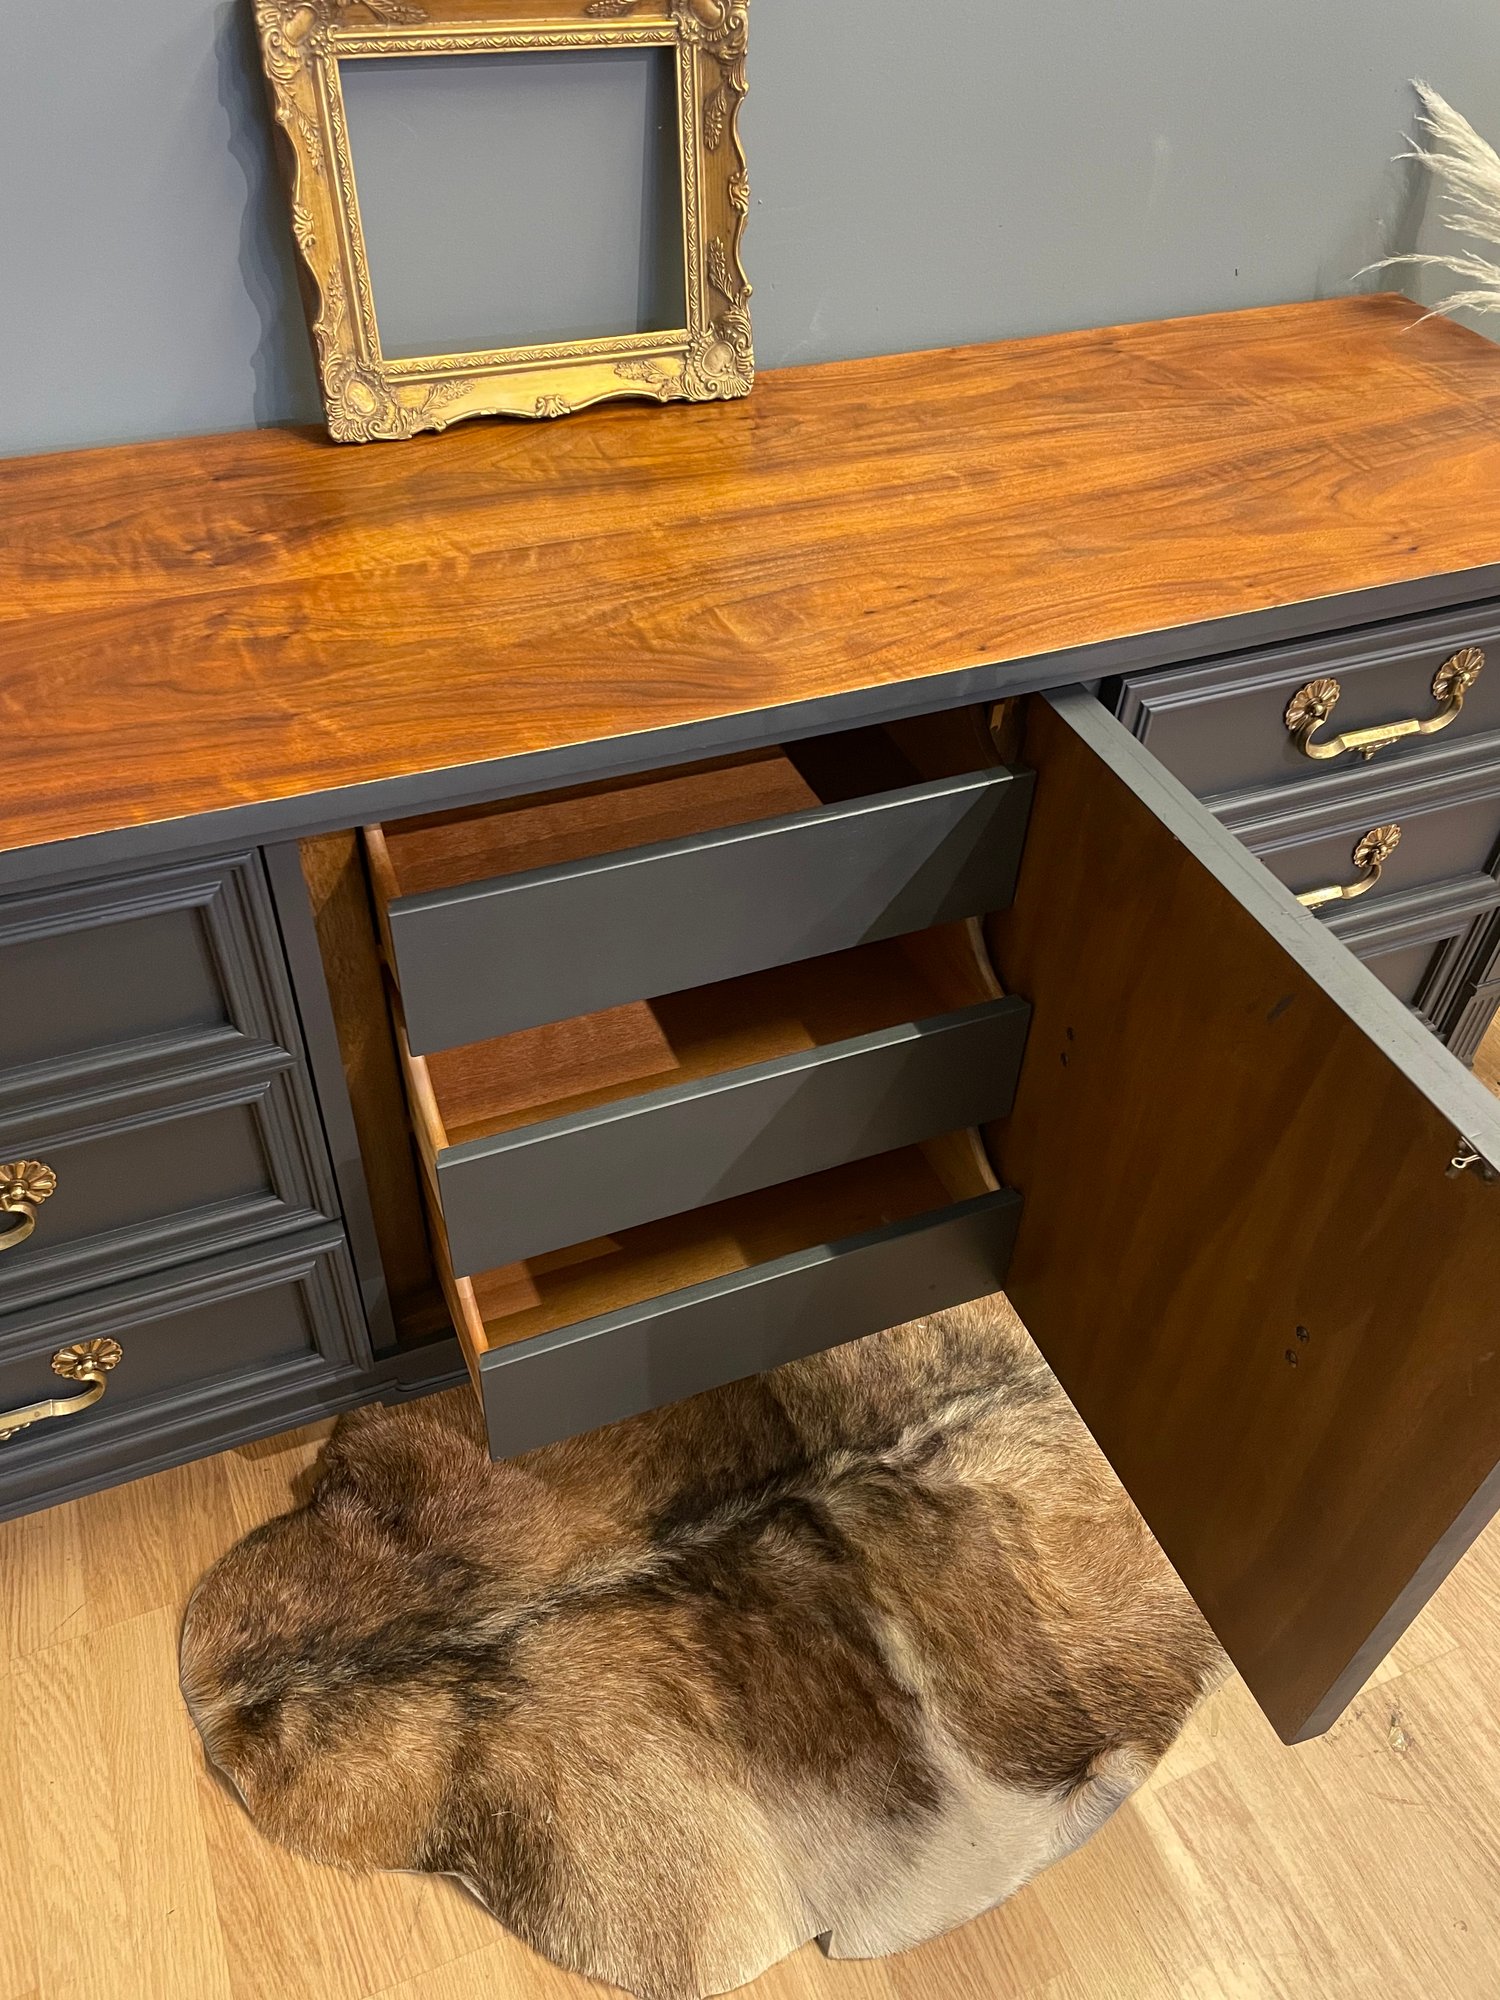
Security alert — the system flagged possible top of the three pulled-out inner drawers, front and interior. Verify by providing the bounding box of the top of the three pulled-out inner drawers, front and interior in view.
[366,730,1030,1056]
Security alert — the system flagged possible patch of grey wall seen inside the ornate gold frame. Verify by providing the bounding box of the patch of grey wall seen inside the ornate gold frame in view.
[340,48,688,360]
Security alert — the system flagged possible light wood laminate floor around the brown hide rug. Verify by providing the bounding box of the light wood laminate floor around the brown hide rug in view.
[0,1036,1500,2000]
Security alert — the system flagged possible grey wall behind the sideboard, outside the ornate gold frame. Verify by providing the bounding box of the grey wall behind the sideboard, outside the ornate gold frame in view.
[0,0,1500,452]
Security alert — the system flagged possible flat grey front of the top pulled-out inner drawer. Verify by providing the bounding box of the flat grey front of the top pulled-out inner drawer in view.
[386,770,1032,1056]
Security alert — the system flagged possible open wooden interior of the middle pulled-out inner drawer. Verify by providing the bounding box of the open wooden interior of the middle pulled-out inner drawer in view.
[410,922,1002,1156]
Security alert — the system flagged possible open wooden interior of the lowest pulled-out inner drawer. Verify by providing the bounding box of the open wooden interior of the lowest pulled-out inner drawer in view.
[444,1132,1012,1370]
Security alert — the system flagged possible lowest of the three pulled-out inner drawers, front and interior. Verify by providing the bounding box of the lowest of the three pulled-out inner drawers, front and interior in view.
[434,1134,1020,1458]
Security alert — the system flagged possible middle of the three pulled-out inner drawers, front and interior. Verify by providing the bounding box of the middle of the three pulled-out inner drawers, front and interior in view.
[406,924,1030,1276]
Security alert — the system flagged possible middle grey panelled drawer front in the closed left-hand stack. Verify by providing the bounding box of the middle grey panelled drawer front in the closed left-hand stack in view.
[0,1062,338,1312]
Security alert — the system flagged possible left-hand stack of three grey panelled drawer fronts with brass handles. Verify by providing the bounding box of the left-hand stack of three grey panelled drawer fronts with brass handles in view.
[0,854,370,1512]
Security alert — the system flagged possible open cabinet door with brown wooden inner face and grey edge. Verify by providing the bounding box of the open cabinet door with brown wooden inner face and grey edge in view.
[994,690,1500,1742]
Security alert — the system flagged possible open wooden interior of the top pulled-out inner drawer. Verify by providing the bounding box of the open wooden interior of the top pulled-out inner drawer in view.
[366,710,1000,902]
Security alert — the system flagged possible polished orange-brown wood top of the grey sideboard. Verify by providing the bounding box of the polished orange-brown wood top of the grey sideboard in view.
[0,296,1500,852]
